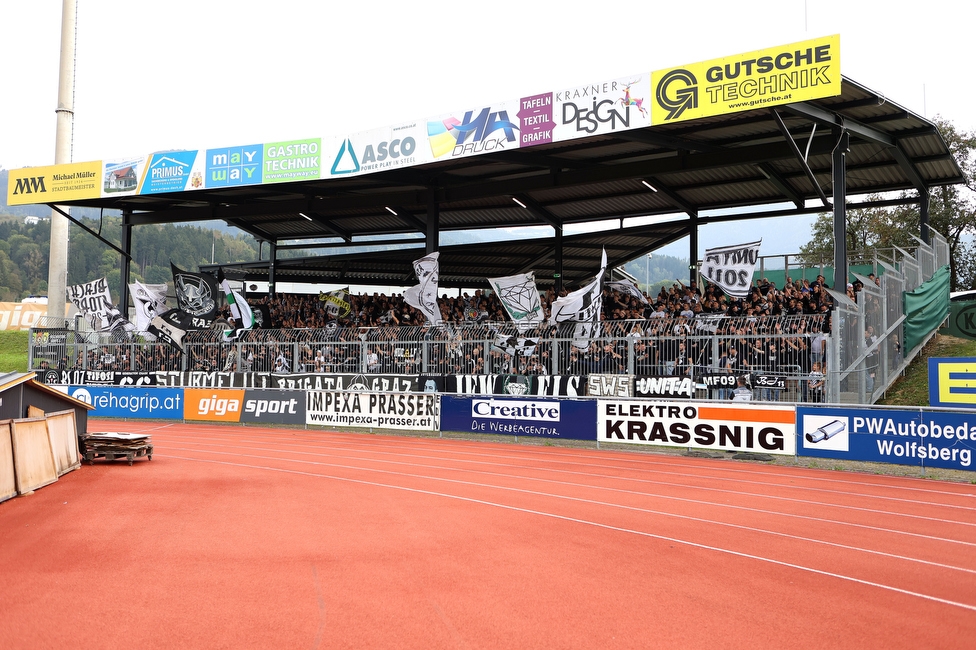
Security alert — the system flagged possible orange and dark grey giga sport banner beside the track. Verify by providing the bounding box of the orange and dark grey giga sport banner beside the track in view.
[183,388,305,424]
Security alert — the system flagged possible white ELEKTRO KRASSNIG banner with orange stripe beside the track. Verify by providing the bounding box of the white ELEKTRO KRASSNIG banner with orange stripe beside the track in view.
[597,400,796,455]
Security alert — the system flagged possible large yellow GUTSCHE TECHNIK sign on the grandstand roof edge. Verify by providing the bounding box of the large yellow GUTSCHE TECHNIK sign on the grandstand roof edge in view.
[651,35,840,125]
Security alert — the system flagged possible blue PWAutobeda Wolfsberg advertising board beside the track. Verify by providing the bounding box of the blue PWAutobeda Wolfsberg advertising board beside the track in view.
[796,406,976,470]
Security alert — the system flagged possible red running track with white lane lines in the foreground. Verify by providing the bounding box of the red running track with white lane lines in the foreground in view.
[0,422,976,649]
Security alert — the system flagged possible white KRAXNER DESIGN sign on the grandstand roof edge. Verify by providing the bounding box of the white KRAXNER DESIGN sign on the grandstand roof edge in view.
[552,73,651,142]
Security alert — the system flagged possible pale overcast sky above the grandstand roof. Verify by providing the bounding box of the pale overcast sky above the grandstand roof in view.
[0,0,976,260]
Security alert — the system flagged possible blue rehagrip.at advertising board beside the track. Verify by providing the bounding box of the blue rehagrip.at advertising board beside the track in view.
[68,386,183,420]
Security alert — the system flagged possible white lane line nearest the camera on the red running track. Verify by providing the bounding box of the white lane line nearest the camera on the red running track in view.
[162,456,976,612]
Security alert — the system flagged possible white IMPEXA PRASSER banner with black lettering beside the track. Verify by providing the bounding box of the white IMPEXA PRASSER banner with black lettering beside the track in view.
[306,390,440,431]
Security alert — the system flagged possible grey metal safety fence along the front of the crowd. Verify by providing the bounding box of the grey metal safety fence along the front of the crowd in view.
[31,314,829,401]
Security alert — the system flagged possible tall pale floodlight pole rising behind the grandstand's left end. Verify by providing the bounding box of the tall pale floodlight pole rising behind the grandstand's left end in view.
[47,0,76,319]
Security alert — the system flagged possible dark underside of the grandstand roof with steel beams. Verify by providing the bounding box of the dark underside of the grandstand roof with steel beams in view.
[51,78,963,287]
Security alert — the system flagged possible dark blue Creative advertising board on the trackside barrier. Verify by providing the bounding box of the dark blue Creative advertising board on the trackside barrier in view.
[441,395,596,440]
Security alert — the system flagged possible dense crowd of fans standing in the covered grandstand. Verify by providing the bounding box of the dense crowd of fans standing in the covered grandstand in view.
[43,276,873,401]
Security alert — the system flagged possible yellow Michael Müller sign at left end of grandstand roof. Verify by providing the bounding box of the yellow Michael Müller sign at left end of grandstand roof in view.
[7,160,102,205]
